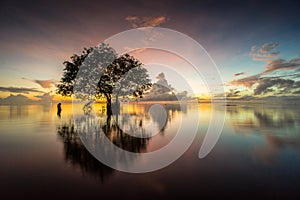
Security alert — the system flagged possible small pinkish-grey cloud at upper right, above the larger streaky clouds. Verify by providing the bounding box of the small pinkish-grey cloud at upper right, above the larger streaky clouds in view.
[249,42,279,61]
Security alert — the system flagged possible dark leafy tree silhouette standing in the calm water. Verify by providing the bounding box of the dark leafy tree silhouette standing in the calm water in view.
[57,43,151,115]
